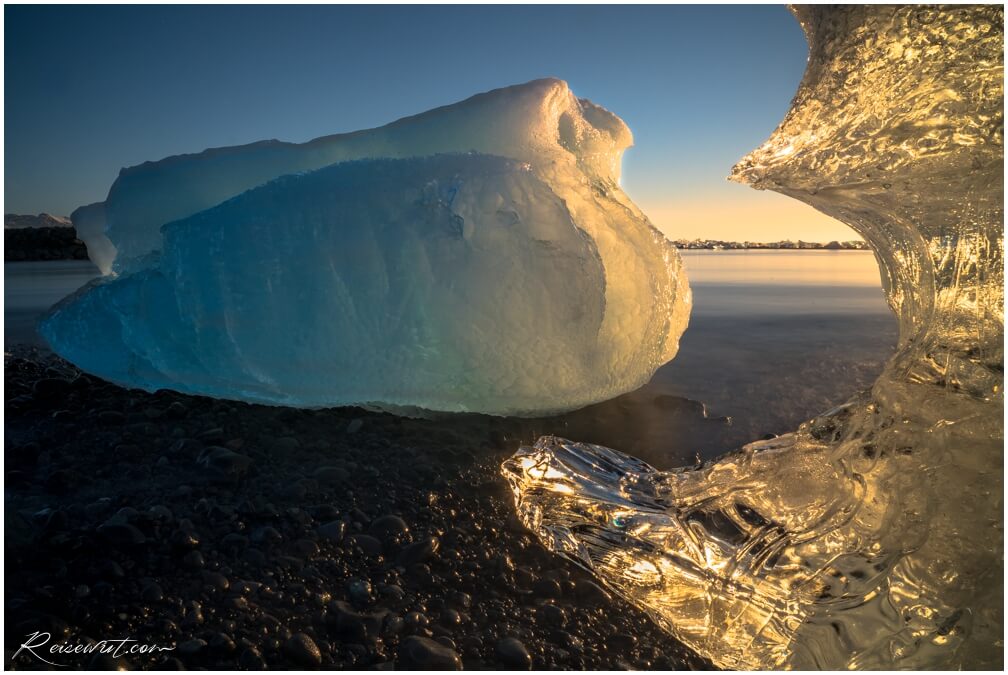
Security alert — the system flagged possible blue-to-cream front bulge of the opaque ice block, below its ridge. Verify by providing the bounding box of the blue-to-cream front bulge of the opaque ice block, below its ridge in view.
[41,148,683,414]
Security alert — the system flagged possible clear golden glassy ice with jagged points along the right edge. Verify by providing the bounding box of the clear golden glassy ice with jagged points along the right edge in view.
[502,5,1004,670]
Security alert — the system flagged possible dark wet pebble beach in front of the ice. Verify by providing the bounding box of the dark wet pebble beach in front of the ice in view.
[4,350,706,670]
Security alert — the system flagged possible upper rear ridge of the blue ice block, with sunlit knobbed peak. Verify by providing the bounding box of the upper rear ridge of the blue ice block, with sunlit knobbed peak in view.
[80,79,639,274]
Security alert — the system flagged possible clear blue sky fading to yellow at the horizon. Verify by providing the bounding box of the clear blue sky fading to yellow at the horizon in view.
[4,5,857,241]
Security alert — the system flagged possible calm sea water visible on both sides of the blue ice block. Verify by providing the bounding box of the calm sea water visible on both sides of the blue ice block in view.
[4,251,897,467]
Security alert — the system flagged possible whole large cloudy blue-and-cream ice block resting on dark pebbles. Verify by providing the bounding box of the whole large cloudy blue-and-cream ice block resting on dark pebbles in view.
[41,80,690,414]
